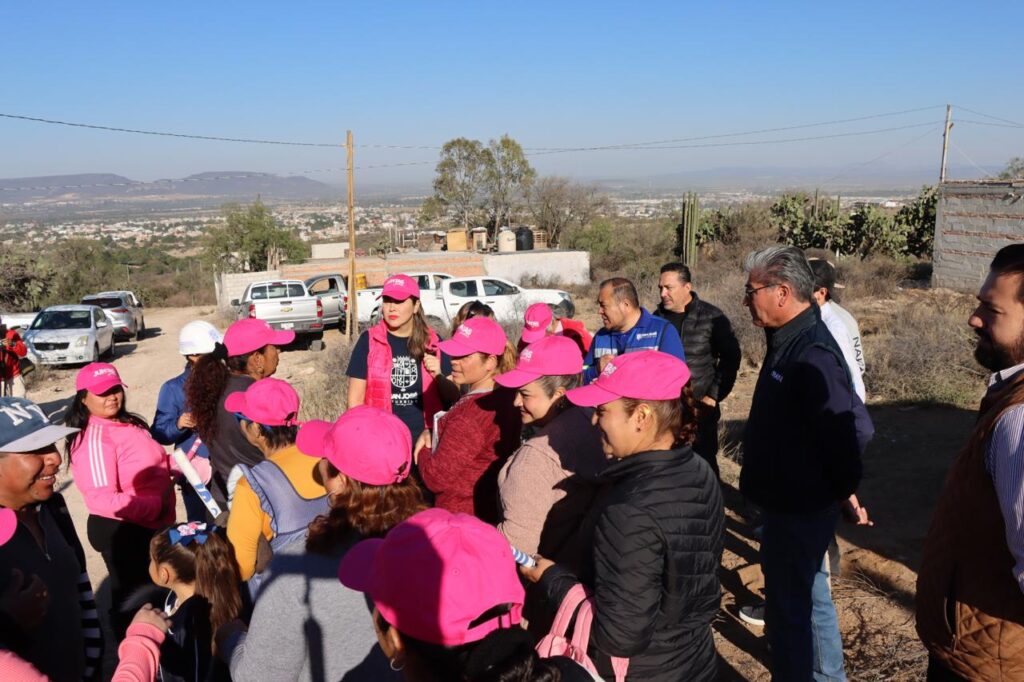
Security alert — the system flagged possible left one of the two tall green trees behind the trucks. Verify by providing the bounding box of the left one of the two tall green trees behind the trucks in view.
[424,137,488,229]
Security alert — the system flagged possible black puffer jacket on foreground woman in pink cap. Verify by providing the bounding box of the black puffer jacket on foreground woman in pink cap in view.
[541,446,725,682]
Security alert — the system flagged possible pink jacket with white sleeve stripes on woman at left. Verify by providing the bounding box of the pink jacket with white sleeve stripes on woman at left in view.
[71,417,174,528]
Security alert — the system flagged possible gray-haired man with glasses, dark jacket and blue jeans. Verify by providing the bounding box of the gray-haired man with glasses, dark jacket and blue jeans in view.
[739,246,873,680]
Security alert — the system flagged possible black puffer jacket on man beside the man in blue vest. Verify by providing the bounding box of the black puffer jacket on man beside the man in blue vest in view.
[654,291,740,402]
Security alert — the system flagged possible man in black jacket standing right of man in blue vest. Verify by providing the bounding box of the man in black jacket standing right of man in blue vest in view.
[654,263,740,477]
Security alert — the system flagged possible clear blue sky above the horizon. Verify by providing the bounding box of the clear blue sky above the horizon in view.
[0,0,1024,182]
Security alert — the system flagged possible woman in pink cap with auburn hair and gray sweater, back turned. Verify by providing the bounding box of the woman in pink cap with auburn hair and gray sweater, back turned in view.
[218,406,425,682]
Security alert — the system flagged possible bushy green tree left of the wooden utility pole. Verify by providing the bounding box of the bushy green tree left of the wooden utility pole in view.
[204,200,308,272]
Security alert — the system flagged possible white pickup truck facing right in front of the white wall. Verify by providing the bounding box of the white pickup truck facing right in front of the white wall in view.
[439,276,575,324]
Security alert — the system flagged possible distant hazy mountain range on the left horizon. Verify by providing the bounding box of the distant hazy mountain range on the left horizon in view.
[0,171,339,205]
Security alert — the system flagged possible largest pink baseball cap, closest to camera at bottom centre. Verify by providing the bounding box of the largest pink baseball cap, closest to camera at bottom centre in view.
[338,509,525,646]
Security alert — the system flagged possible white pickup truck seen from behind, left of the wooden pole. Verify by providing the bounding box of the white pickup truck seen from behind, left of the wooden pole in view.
[231,280,325,335]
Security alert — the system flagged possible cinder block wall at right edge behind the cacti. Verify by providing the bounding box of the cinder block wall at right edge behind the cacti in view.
[932,180,1024,293]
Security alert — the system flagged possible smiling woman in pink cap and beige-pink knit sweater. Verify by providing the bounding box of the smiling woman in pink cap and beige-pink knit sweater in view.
[495,336,605,566]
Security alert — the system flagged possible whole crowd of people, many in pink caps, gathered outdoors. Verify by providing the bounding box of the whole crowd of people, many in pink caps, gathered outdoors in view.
[0,246,1024,682]
